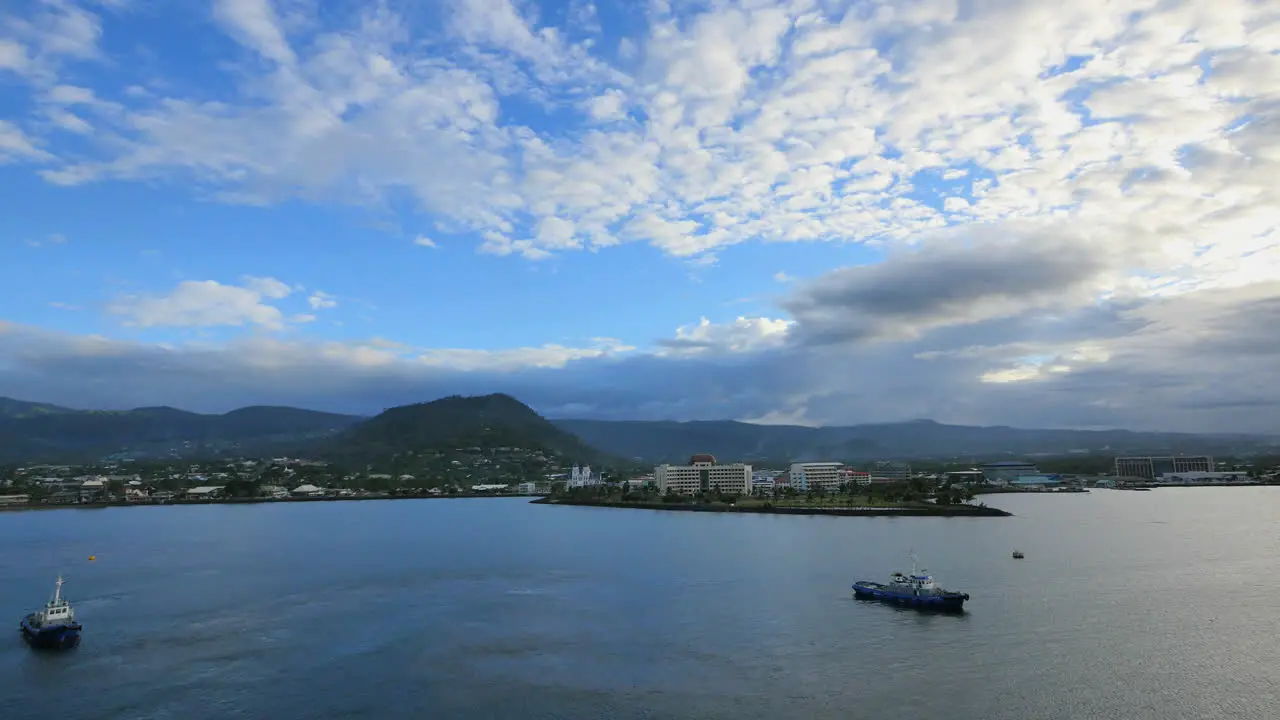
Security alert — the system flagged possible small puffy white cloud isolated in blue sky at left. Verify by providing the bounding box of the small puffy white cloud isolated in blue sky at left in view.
[108,277,292,331]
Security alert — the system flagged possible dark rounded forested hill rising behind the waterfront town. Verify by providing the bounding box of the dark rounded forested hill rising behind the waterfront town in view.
[324,393,603,462]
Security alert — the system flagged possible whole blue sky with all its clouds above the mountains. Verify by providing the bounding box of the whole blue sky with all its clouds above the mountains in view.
[0,0,1280,433]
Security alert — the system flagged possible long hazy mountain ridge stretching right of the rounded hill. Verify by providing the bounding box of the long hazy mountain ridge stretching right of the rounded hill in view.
[554,412,1277,462]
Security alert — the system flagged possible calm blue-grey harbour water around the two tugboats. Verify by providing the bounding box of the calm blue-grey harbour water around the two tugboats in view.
[0,488,1280,720]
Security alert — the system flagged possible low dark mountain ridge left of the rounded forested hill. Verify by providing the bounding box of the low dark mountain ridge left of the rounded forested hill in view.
[0,398,362,461]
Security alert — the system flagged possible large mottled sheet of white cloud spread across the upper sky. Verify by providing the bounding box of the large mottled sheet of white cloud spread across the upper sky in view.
[3,0,1280,277]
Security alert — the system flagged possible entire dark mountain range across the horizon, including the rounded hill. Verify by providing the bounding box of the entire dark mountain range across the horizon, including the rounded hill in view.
[0,395,1280,462]
